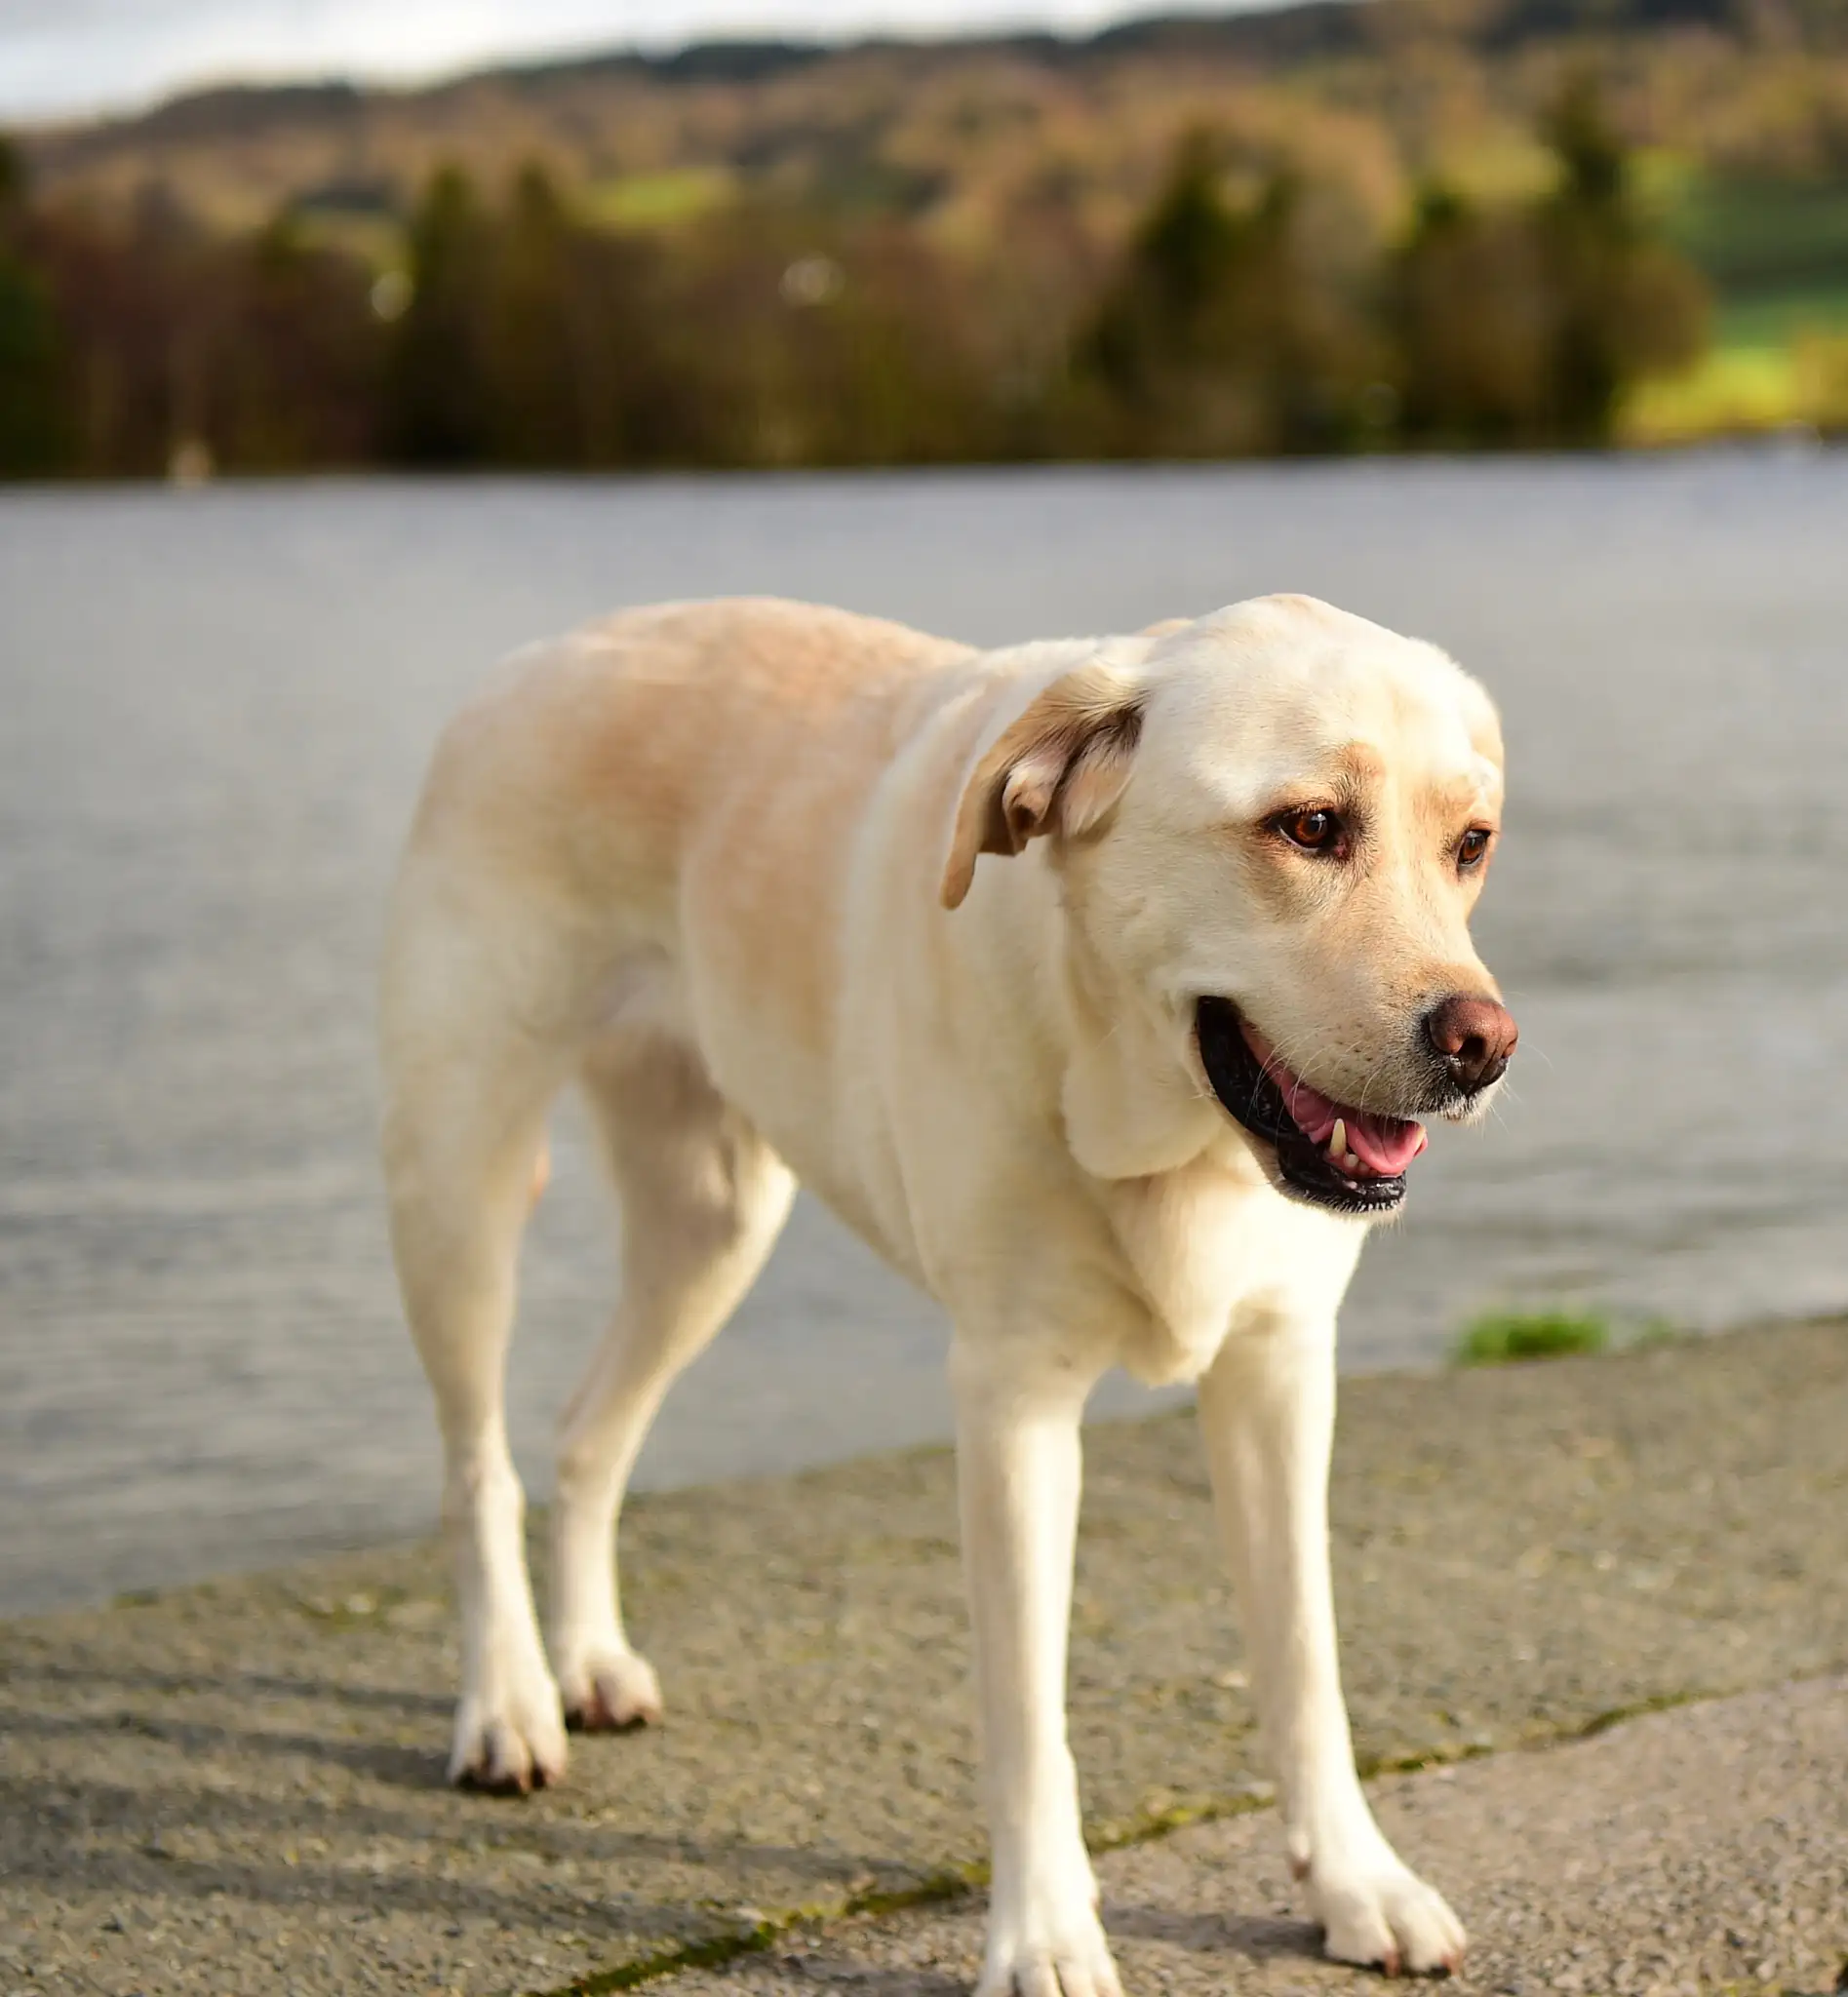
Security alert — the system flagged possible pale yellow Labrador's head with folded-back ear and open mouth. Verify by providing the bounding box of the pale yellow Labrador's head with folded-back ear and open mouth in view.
[943,597,1514,1216]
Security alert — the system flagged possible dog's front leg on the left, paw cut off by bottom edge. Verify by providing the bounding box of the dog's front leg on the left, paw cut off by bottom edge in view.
[951,1342,1121,1997]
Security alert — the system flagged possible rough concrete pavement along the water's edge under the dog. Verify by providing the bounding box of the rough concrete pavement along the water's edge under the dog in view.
[0,1324,1848,1997]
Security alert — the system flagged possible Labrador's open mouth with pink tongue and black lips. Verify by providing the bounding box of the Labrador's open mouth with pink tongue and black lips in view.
[1195,998,1427,1214]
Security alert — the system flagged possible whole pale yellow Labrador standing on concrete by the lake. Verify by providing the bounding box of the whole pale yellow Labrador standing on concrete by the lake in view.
[383,597,1514,1997]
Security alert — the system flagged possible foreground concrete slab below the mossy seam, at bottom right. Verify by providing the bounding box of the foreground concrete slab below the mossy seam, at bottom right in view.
[639,1673,1848,1997]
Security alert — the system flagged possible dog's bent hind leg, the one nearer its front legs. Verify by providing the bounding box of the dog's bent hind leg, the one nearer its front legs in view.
[551,1033,795,1730]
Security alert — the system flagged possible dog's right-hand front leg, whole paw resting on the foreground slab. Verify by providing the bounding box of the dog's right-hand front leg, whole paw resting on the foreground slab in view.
[1200,1322,1465,1971]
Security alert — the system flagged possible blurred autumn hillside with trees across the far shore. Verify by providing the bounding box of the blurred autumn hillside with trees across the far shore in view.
[0,0,1848,469]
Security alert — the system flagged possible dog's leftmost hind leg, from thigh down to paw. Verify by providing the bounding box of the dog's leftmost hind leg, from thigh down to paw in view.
[381,888,571,1791]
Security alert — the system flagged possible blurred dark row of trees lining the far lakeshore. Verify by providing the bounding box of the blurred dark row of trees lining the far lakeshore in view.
[0,87,1704,475]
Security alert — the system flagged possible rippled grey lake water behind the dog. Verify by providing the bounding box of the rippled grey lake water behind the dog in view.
[0,451,1848,1608]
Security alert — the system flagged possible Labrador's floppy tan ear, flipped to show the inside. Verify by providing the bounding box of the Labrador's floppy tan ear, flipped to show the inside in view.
[941,659,1143,909]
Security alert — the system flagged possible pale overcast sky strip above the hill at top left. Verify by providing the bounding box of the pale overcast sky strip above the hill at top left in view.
[0,0,1237,118]
